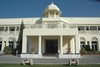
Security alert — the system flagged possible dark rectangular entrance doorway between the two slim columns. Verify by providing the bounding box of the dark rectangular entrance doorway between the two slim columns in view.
[45,39,58,55]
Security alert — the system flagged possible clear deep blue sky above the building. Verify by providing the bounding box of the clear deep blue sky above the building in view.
[0,0,100,18]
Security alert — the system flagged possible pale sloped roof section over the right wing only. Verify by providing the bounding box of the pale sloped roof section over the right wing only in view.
[62,17,100,24]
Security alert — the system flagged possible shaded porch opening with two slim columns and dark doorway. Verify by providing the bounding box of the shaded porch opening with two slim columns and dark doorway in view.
[27,36,74,56]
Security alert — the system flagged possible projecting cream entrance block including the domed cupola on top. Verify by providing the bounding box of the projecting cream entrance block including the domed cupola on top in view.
[21,3,80,58]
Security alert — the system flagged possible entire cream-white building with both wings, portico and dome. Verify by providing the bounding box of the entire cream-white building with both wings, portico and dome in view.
[0,3,100,58]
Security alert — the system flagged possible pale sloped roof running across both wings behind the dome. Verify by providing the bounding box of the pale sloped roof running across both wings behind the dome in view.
[0,17,100,24]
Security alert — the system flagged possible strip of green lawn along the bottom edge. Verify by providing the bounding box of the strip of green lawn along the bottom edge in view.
[0,64,100,67]
